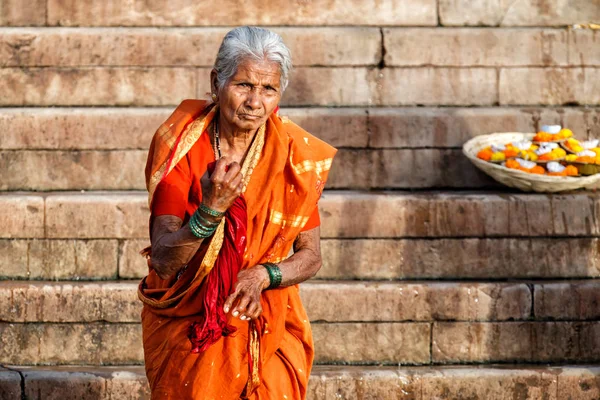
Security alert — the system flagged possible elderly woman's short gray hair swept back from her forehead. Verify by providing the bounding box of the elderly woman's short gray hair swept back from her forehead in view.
[214,26,292,93]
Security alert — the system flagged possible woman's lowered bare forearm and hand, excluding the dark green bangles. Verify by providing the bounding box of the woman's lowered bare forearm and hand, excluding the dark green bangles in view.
[223,227,322,320]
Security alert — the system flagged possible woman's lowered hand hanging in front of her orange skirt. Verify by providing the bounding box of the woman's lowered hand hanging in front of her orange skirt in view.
[223,264,270,321]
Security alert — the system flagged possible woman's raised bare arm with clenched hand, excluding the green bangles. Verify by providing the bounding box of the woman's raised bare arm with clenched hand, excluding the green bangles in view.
[150,157,242,279]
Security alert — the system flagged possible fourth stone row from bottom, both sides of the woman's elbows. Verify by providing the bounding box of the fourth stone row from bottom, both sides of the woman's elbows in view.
[0,237,600,280]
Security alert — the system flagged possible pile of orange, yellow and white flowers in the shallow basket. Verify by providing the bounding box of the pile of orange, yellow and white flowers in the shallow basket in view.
[477,125,600,176]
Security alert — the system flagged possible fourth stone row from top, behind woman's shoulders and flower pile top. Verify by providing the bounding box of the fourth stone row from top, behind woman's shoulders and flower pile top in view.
[0,107,600,151]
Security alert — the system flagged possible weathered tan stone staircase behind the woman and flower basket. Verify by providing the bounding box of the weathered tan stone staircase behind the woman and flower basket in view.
[0,0,600,400]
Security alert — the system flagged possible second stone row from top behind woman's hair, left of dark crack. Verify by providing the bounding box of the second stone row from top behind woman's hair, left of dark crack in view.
[0,26,380,67]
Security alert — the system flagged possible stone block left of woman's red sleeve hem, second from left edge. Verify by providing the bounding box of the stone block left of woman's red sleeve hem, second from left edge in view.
[46,192,150,239]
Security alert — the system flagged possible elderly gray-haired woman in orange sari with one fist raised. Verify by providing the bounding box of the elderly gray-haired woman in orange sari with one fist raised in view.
[139,27,336,400]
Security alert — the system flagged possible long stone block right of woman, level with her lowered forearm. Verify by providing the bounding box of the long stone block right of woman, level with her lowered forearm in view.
[317,238,600,280]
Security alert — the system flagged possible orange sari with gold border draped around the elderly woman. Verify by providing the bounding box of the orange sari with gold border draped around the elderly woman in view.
[138,100,336,400]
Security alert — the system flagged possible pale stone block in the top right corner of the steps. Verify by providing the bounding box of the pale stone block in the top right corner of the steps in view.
[439,0,600,26]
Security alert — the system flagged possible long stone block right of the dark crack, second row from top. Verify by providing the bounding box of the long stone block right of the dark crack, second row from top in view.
[383,28,567,67]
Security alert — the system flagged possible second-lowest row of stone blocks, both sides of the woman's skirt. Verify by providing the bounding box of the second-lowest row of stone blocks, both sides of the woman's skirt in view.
[7,321,600,365]
